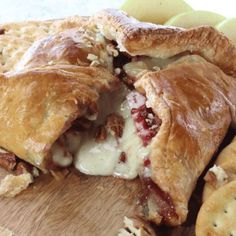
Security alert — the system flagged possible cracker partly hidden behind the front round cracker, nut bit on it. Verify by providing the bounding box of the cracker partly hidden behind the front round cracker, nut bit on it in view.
[202,161,236,202]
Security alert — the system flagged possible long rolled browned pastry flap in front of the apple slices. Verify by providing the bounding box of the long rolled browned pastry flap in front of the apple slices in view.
[94,9,236,76]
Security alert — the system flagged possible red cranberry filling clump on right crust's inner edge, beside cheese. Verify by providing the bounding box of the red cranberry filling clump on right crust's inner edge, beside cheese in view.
[127,91,161,146]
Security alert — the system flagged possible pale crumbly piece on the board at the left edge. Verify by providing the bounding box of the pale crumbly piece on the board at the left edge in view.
[0,173,33,197]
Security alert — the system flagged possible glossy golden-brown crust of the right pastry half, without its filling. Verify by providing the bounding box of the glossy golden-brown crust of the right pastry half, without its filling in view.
[135,56,236,225]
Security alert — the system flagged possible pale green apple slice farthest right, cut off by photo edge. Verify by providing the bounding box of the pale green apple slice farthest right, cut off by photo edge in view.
[216,18,236,45]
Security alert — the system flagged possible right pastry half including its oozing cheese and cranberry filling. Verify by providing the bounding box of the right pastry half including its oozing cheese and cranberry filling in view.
[76,53,236,225]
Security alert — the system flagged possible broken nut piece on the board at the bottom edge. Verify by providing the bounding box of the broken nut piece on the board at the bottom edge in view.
[118,217,156,236]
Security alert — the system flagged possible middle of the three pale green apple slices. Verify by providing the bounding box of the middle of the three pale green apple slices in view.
[165,11,225,29]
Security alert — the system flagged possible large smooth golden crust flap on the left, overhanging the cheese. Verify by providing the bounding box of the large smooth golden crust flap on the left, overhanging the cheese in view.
[0,65,117,169]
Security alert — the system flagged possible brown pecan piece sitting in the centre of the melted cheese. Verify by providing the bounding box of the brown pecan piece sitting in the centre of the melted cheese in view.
[106,113,125,138]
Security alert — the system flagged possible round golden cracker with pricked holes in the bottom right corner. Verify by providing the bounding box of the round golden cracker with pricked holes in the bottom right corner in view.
[196,181,236,236]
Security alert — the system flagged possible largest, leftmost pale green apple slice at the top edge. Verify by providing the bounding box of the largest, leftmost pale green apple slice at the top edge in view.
[121,0,193,24]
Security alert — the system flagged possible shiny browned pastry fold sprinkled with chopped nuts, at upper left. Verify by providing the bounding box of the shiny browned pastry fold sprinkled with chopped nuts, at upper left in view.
[15,26,112,71]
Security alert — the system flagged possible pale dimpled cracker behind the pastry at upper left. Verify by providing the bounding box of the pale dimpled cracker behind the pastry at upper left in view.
[0,16,88,72]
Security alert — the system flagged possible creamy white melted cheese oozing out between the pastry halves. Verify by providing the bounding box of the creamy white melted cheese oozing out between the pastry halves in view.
[75,88,149,179]
